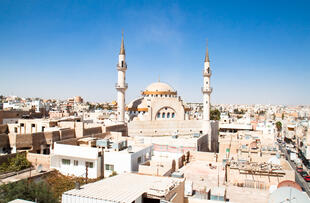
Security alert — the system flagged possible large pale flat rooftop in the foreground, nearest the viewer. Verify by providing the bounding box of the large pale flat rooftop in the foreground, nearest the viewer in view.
[62,173,184,202]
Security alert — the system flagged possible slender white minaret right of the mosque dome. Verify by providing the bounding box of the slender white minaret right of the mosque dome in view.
[202,41,212,121]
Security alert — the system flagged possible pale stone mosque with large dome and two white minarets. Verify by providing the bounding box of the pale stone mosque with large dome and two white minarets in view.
[116,32,218,151]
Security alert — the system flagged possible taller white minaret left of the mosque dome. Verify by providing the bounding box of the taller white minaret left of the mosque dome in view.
[115,33,128,123]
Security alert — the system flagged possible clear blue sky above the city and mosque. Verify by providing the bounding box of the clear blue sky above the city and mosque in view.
[0,0,310,104]
